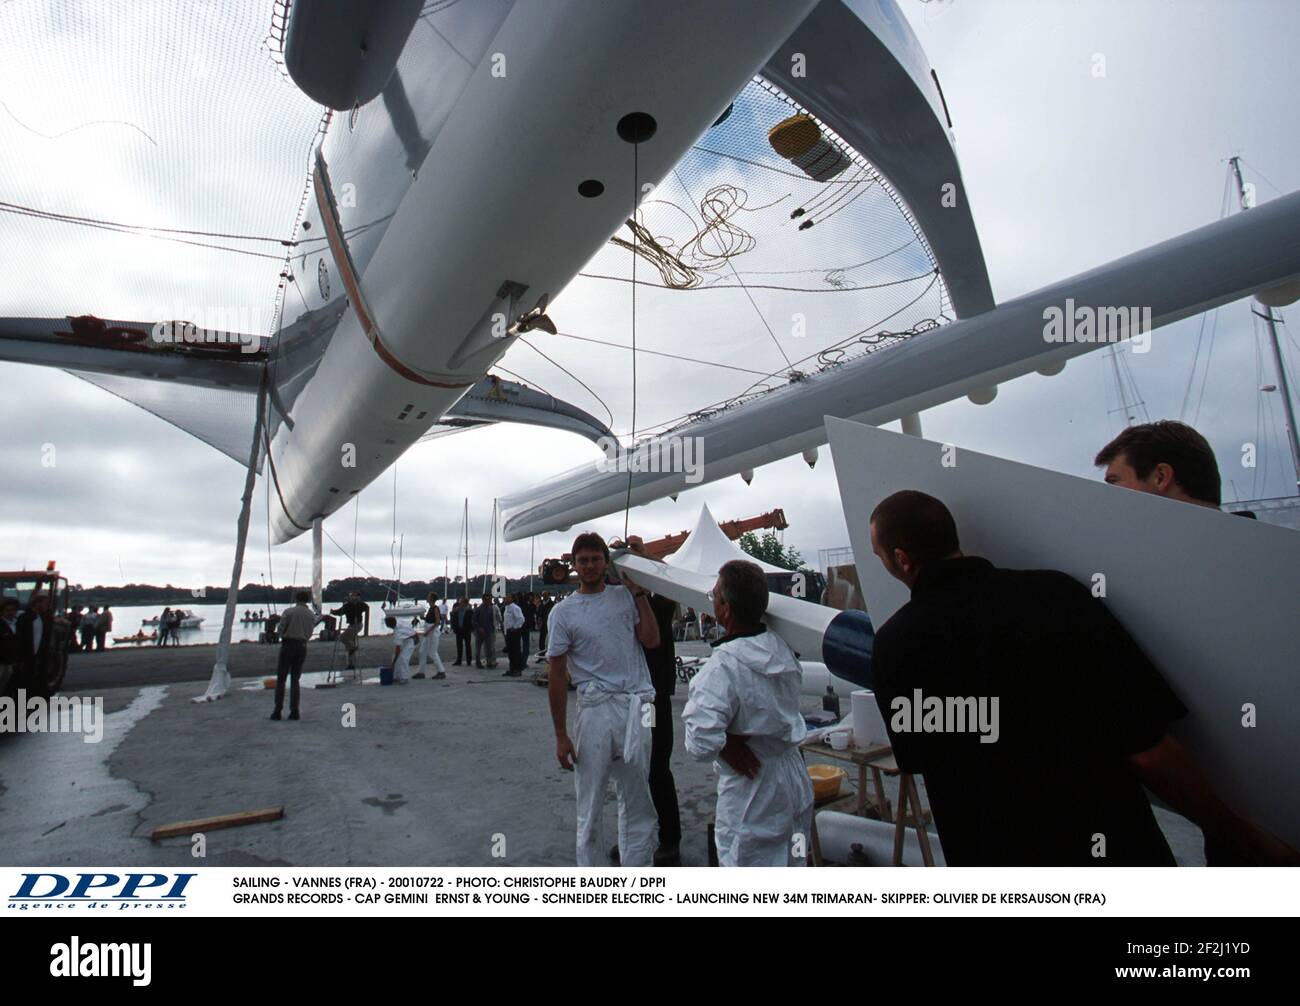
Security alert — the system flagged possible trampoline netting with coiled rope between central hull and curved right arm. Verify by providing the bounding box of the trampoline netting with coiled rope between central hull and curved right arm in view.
[498,78,950,438]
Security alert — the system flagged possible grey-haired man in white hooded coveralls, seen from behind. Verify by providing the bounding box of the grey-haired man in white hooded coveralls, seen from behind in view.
[681,559,813,867]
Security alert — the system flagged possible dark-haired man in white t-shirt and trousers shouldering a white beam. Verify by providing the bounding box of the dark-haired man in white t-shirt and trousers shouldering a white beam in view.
[546,532,659,866]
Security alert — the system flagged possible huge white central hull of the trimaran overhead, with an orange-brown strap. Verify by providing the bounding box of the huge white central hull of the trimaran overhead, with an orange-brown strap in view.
[258,0,815,542]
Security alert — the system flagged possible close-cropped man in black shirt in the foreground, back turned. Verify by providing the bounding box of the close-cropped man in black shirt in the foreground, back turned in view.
[871,490,1296,866]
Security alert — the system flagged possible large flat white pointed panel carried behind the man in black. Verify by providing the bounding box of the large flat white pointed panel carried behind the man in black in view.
[826,417,1300,847]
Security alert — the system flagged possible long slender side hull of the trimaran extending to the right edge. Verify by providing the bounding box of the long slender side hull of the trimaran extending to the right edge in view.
[502,194,1300,541]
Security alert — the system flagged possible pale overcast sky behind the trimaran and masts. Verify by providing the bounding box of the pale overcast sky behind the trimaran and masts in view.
[0,0,1300,586]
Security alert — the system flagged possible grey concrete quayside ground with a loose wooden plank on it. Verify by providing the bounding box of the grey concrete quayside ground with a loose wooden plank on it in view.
[0,637,1204,867]
